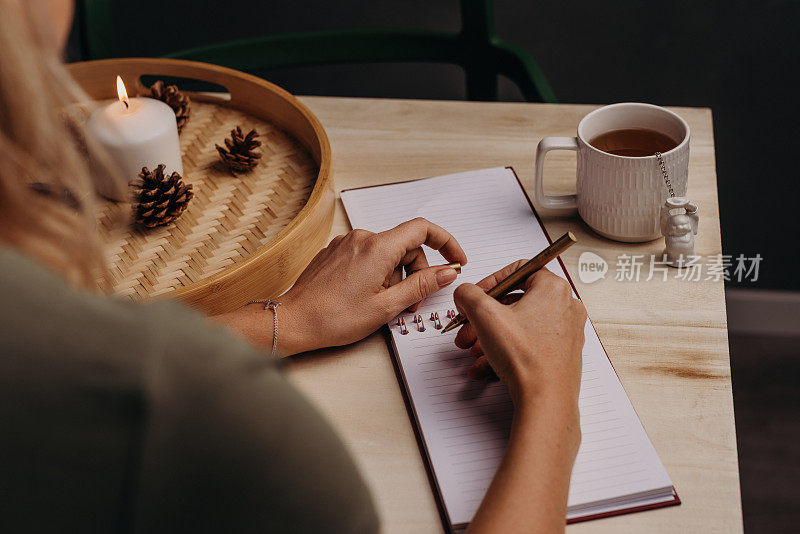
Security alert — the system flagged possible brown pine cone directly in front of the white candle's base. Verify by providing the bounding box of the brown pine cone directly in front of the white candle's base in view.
[131,164,194,228]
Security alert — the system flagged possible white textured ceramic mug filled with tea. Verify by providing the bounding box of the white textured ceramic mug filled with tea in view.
[533,102,689,242]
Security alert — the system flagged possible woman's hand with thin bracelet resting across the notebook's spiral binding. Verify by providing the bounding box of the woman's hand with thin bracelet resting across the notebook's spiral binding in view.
[219,218,467,356]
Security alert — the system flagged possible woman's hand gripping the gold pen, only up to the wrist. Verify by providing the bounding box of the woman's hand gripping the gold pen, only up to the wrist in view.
[454,260,586,413]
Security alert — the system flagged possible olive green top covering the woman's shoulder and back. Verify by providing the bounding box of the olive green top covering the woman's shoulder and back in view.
[0,250,378,533]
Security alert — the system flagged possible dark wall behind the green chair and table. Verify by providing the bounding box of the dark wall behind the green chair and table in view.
[73,0,800,290]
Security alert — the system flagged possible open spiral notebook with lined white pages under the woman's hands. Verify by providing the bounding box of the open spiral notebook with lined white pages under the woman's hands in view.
[342,167,680,531]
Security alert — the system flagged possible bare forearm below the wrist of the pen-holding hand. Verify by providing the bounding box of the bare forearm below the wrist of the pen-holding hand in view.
[469,395,580,533]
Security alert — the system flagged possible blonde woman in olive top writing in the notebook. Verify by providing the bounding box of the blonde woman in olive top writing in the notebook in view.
[0,0,586,532]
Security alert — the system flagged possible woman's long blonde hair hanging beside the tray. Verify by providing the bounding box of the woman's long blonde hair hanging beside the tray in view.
[0,0,119,288]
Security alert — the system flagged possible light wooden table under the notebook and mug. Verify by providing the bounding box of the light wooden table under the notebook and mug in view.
[290,97,742,533]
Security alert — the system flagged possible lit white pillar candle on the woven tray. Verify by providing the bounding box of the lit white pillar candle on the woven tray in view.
[86,76,183,200]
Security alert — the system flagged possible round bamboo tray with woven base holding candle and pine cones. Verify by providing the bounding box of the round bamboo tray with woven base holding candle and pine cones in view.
[69,58,334,314]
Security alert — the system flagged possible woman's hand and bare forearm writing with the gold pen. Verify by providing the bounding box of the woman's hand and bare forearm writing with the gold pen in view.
[455,260,586,534]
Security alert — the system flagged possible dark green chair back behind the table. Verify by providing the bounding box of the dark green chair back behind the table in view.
[79,0,557,103]
